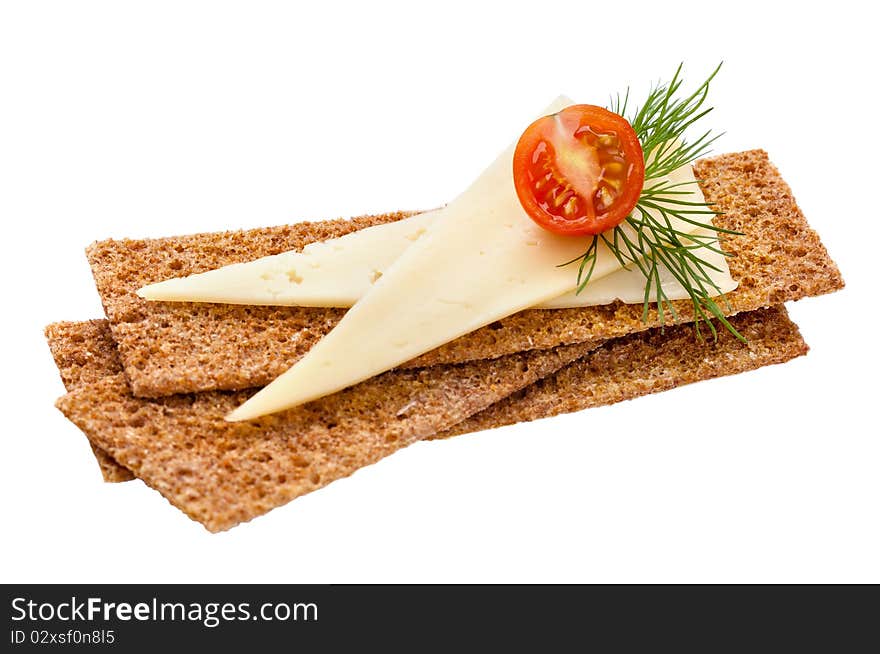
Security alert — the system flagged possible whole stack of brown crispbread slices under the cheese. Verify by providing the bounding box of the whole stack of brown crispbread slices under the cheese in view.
[47,151,843,531]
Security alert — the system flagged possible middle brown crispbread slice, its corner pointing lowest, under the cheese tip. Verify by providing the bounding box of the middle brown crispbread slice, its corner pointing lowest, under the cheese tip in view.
[57,343,591,531]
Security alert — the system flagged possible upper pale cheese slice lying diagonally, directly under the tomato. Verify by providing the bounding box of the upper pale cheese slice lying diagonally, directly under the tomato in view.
[228,99,728,420]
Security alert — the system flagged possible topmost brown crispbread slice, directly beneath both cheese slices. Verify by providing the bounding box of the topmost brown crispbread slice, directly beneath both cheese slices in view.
[88,150,843,397]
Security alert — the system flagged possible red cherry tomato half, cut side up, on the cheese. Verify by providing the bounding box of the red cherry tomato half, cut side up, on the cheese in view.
[513,104,645,236]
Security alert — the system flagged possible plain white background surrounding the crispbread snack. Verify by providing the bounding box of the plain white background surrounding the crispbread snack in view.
[0,0,880,582]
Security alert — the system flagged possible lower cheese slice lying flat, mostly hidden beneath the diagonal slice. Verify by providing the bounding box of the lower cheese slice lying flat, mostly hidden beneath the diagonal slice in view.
[138,166,736,309]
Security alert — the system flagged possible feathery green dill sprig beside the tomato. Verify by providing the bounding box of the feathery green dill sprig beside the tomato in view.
[562,64,745,342]
